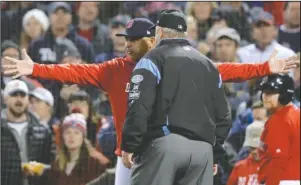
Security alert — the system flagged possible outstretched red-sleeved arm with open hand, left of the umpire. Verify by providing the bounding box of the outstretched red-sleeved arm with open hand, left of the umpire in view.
[3,50,126,90]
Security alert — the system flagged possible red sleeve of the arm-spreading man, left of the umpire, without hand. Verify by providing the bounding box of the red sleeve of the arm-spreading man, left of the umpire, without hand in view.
[32,59,118,91]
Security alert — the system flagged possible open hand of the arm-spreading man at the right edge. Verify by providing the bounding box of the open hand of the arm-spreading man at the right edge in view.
[268,50,300,74]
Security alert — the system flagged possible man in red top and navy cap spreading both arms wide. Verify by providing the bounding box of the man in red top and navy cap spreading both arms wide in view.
[3,18,300,185]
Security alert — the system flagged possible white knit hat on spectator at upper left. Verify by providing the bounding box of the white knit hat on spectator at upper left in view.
[22,9,49,31]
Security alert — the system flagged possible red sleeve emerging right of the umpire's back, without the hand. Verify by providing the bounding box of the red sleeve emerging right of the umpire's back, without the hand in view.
[216,62,271,82]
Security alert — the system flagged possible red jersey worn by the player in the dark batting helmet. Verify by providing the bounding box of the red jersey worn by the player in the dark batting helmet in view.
[259,105,300,185]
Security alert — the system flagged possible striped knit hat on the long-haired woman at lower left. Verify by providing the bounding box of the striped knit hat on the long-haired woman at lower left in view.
[62,113,87,135]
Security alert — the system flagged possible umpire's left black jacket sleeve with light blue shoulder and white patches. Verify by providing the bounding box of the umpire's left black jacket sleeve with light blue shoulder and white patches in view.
[121,58,161,153]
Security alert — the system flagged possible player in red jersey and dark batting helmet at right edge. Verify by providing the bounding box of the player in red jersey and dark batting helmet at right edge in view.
[258,75,300,185]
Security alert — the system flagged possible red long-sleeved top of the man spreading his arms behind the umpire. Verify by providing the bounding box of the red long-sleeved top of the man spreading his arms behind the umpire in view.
[32,57,270,156]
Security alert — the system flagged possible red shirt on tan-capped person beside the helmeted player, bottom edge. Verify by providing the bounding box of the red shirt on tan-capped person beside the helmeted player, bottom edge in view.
[227,154,259,185]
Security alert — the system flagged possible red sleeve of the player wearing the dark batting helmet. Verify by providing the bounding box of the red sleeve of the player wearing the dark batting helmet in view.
[259,119,290,185]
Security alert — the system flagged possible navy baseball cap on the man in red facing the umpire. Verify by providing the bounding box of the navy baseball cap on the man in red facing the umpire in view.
[116,18,156,37]
